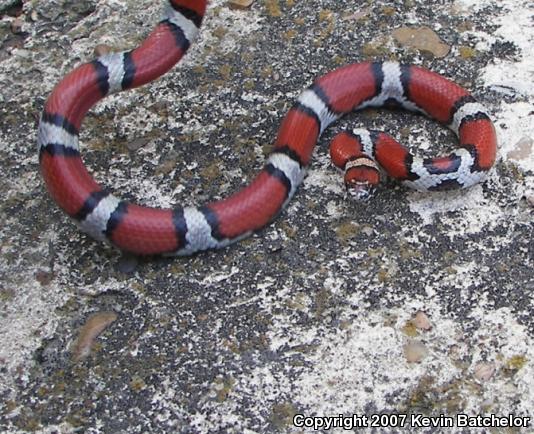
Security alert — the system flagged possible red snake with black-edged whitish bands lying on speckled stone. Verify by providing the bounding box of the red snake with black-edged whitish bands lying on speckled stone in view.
[37,0,497,255]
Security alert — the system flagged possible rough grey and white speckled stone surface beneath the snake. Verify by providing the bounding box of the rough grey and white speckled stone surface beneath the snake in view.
[0,0,534,434]
